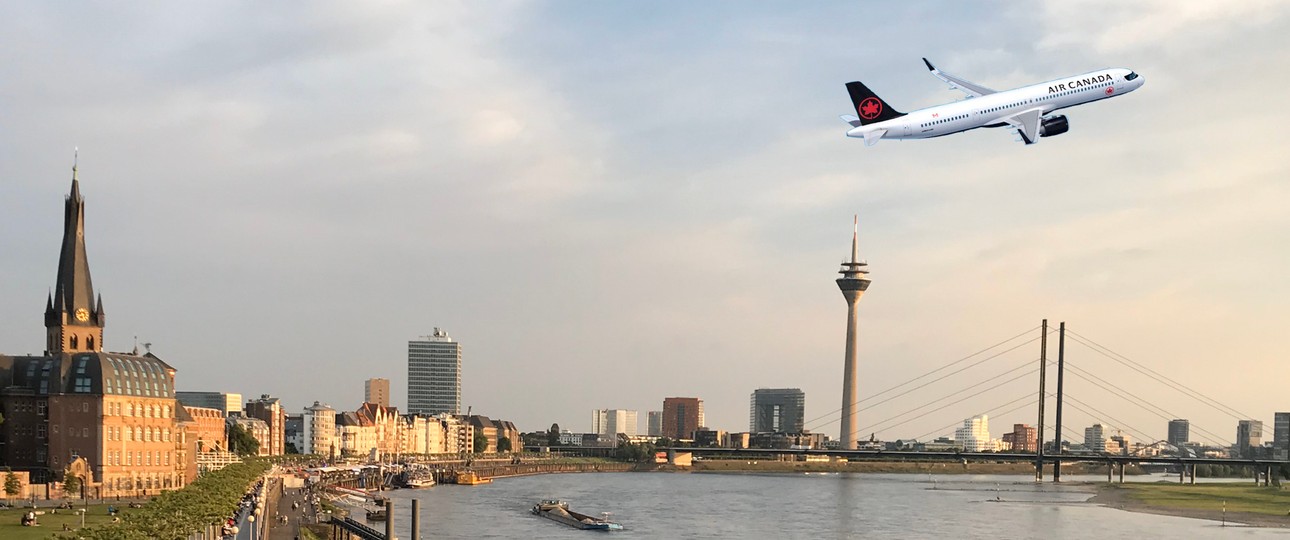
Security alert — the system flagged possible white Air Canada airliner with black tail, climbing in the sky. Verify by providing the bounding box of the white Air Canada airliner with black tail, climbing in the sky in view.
[842,58,1146,146]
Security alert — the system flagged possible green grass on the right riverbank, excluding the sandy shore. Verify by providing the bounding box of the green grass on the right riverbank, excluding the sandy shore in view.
[1121,483,1290,516]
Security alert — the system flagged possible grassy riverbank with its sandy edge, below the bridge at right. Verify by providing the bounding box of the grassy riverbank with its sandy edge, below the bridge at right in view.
[1089,483,1290,528]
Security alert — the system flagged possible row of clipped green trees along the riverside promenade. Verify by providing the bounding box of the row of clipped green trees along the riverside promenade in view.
[62,459,271,540]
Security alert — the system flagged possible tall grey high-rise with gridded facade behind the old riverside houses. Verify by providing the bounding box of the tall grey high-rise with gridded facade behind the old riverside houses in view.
[408,329,462,415]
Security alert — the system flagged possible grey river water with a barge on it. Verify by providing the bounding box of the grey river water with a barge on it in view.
[373,473,1290,540]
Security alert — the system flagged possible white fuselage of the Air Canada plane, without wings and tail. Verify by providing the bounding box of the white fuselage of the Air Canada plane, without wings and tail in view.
[846,68,1144,139]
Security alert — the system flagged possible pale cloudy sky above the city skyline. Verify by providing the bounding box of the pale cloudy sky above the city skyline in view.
[0,0,1290,443]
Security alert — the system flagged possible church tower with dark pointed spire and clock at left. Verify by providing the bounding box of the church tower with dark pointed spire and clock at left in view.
[45,164,104,354]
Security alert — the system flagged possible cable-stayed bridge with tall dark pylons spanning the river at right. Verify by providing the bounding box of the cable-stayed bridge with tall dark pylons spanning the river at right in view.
[679,321,1287,479]
